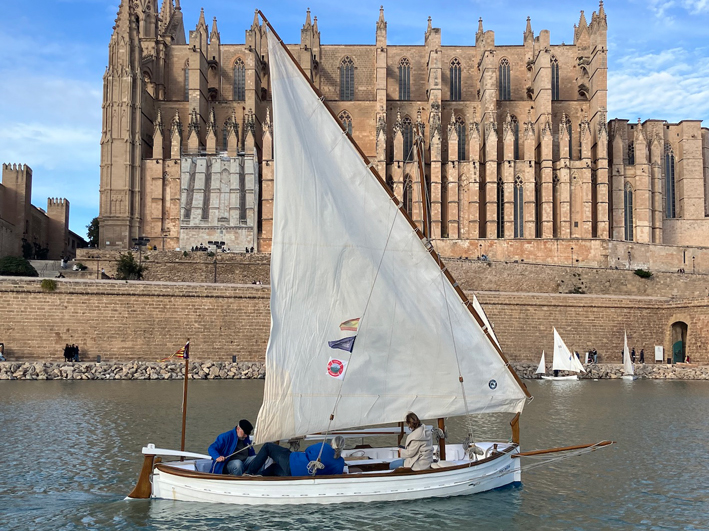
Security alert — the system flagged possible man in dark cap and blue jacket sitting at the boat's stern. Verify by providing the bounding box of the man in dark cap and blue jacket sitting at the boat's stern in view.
[195,419,256,476]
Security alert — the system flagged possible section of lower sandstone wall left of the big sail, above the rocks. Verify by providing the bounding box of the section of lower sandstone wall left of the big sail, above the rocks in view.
[0,277,270,361]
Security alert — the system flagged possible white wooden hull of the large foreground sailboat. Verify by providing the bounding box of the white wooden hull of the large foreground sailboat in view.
[145,443,521,505]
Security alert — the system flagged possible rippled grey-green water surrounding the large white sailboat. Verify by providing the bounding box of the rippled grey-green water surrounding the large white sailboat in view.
[0,380,709,530]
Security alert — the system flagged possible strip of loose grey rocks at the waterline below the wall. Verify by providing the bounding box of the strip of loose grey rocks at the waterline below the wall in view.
[0,361,709,380]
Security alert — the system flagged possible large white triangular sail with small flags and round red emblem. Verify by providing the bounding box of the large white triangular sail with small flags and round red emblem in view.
[256,29,526,443]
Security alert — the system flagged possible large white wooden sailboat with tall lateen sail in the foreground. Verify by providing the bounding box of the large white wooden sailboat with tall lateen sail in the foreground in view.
[129,12,610,505]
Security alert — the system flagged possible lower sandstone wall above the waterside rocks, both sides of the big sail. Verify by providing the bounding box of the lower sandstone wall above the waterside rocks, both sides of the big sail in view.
[0,277,709,363]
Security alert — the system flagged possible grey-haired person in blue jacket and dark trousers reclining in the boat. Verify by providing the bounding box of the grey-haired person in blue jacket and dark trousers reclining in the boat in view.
[244,437,345,476]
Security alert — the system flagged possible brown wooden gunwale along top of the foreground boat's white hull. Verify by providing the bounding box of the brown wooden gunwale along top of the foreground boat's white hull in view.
[154,443,519,481]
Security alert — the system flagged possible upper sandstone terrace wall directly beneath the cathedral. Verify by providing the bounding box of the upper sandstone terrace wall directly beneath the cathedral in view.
[77,249,709,298]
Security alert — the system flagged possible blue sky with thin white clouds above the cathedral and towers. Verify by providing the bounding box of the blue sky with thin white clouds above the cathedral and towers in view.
[0,0,709,235]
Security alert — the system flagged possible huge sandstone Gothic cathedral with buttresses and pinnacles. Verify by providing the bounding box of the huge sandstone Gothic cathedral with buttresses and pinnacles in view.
[100,0,709,263]
